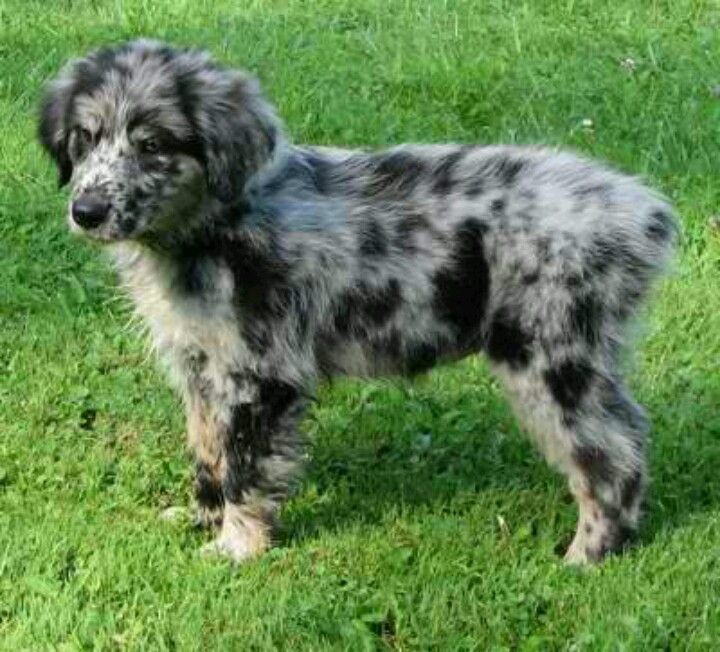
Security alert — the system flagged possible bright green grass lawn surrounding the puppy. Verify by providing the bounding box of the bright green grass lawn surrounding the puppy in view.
[0,0,720,650]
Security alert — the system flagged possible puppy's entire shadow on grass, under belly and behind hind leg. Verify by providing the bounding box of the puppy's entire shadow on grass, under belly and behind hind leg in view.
[278,372,720,549]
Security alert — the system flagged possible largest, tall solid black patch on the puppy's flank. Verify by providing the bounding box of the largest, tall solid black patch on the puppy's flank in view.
[433,218,490,344]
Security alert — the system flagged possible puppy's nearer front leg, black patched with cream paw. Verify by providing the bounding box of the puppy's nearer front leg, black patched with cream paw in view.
[200,373,305,561]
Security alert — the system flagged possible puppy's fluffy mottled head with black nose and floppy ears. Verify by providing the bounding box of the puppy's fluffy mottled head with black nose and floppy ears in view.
[39,41,281,241]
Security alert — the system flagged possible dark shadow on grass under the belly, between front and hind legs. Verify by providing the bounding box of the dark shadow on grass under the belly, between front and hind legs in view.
[279,376,571,543]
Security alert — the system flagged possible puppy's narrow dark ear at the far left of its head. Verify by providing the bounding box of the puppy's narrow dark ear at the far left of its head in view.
[38,79,74,186]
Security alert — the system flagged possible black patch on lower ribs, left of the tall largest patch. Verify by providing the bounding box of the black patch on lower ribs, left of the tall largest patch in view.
[335,279,402,335]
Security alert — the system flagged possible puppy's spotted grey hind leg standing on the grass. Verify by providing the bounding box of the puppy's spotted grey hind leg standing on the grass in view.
[497,359,647,564]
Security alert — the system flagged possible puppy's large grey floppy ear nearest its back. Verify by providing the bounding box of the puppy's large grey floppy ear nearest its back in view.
[195,69,281,203]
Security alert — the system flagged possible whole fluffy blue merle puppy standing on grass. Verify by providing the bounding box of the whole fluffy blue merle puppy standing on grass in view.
[39,40,678,564]
